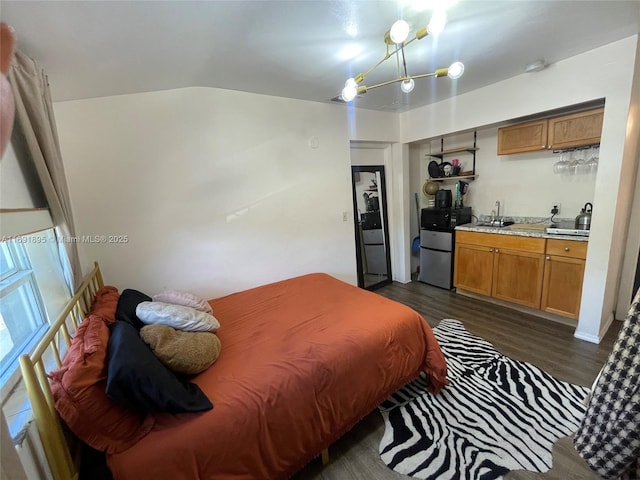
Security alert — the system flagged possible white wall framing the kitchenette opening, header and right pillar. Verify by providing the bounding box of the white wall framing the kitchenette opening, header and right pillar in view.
[400,36,638,341]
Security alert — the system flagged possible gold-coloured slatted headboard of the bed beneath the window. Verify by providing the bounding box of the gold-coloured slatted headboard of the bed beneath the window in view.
[20,262,103,480]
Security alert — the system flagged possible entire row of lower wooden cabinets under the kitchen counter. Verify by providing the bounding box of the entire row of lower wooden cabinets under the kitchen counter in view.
[453,231,587,319]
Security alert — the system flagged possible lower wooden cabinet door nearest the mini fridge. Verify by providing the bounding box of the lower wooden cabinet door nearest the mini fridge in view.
[453,243,493,295]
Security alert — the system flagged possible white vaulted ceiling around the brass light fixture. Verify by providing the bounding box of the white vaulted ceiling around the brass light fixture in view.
[0,0,640,111]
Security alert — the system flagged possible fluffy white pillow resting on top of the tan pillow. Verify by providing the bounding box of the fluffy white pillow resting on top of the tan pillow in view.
[136,302,220,332]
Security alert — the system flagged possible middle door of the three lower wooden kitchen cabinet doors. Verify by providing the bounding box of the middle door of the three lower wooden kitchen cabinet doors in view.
[491,248,544,308]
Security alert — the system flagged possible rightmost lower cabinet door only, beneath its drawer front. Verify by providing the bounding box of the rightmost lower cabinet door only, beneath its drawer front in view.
[540,255,585,319]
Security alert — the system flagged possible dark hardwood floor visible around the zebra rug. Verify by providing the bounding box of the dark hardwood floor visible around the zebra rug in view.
[293,282,621,480]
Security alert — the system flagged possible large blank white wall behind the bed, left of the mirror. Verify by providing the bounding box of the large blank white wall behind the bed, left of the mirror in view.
[54,88,366,298]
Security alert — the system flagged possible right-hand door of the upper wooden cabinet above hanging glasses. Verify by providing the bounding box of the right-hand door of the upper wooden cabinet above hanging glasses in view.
[548,108,604,150]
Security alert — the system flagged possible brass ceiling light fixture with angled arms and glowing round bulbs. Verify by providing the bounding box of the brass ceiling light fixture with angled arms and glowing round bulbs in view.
[341,19,464,102]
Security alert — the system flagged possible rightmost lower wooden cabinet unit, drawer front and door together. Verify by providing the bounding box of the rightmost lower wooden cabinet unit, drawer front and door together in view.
[540,240,587,319]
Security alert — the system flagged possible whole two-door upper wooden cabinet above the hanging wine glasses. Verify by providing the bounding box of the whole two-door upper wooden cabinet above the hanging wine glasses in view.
[498,108,604,155]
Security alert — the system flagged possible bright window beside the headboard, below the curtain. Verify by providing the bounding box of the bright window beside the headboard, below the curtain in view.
[0,228,70,385]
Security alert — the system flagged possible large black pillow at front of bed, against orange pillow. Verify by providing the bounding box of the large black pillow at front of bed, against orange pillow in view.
[107,321,213,413]
